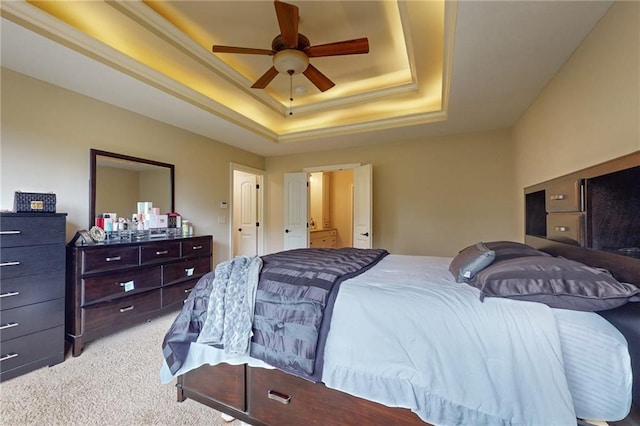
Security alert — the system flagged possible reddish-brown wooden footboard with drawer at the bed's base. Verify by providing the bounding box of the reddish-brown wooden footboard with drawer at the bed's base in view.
[177,364,426,426]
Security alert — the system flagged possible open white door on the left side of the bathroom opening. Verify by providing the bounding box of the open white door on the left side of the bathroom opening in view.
[284,172,309,250]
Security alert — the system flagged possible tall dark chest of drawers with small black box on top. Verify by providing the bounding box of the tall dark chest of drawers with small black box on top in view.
[0,213,66,380]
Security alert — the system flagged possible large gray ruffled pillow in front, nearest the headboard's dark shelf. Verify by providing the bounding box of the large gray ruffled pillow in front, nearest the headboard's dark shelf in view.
[469,256,640,311]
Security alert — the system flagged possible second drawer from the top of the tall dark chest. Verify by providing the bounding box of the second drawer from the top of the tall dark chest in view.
[0,244,65,281]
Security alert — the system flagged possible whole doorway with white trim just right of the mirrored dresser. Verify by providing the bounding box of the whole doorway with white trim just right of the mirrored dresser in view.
[229,164,265,257]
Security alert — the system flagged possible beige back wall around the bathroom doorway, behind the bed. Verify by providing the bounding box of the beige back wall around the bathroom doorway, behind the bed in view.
[266,130,522,256]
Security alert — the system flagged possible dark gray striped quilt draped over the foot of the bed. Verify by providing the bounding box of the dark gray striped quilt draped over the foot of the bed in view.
[162,248,388,382]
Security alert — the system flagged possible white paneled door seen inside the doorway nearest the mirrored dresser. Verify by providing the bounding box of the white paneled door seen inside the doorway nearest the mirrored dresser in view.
[232,170,258,256]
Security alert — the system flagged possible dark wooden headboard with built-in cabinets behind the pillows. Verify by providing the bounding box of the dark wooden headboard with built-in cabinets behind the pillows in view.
[525,151,640,407]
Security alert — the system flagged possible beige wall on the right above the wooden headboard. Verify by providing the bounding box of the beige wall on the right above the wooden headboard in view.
[513,2,640,234]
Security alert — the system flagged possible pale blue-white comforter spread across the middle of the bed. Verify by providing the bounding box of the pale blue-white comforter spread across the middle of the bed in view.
[323,255,629,425]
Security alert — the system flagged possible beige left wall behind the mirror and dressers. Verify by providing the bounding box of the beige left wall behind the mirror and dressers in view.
[0,69,264,261]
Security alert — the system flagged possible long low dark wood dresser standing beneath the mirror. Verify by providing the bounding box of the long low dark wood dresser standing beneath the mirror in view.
[66,236,213,356]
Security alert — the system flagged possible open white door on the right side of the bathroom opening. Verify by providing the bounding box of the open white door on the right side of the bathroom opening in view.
[353,164,373,248]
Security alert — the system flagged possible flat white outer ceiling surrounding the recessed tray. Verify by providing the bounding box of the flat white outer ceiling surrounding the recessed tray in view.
[0,1,611,156]
